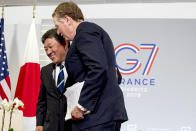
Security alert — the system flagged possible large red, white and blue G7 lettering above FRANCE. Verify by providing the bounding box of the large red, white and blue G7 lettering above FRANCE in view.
[115,43,159,75]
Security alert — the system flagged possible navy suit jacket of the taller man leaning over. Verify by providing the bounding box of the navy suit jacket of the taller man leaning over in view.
[65,22,128,129]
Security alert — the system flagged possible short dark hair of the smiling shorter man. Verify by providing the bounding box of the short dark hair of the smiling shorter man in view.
[41,28,65,44]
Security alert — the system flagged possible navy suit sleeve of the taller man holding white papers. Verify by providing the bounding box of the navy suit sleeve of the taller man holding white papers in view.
[76,32,108,111]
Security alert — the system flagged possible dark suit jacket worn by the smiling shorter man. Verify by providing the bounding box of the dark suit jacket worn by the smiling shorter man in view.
[36,63,67,131]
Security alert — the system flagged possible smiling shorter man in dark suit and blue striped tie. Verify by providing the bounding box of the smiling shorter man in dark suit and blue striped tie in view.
[36,29,71,131]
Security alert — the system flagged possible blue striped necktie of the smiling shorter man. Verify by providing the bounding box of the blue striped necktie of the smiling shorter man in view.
[57,64,65,92]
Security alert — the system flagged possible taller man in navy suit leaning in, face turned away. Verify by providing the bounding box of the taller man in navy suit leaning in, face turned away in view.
[52,2,128,131]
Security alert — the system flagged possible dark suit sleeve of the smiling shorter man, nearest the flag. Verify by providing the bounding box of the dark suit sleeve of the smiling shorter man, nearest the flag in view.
[36,70,46,126]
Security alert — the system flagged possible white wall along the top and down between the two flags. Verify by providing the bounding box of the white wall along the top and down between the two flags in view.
[0,3,196,95]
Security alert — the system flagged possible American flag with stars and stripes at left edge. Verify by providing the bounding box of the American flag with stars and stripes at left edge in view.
[0,18,11,101]
